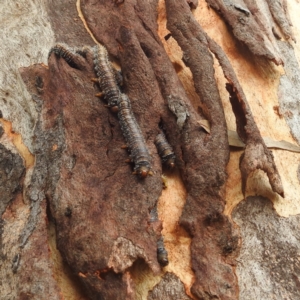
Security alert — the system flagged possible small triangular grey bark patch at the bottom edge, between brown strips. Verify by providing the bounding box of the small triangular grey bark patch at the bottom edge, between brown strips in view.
[147,272,191,300]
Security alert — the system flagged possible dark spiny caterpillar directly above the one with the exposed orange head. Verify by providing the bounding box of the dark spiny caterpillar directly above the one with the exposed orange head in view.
[93,45,121,111]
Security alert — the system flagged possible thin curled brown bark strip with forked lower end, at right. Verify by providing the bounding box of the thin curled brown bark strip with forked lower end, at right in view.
[207,36,284,197]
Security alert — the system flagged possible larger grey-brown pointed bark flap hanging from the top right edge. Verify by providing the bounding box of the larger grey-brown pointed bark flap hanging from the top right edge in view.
[206,0,283,65]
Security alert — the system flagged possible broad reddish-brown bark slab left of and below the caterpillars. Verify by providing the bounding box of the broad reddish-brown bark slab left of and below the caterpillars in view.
[23,46,162,299]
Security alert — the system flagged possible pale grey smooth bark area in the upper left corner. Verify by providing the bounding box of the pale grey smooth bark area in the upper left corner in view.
[0,0,54,152]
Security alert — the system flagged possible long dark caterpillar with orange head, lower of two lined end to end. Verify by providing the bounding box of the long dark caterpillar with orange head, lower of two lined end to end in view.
[118,94,152,178]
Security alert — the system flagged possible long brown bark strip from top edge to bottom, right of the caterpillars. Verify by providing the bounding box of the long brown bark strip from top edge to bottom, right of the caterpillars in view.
[166,0,238,299]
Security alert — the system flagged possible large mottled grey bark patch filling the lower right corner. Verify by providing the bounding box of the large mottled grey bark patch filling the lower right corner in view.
[233,197,300,300]
